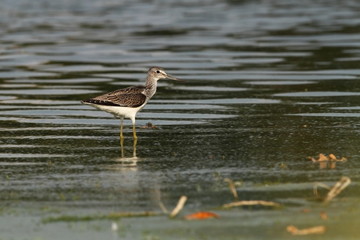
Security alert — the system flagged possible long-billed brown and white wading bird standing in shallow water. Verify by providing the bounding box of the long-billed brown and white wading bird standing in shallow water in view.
[81,67,182,140]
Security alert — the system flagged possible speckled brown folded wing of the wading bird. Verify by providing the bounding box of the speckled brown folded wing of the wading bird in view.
[83,86,146,108]
